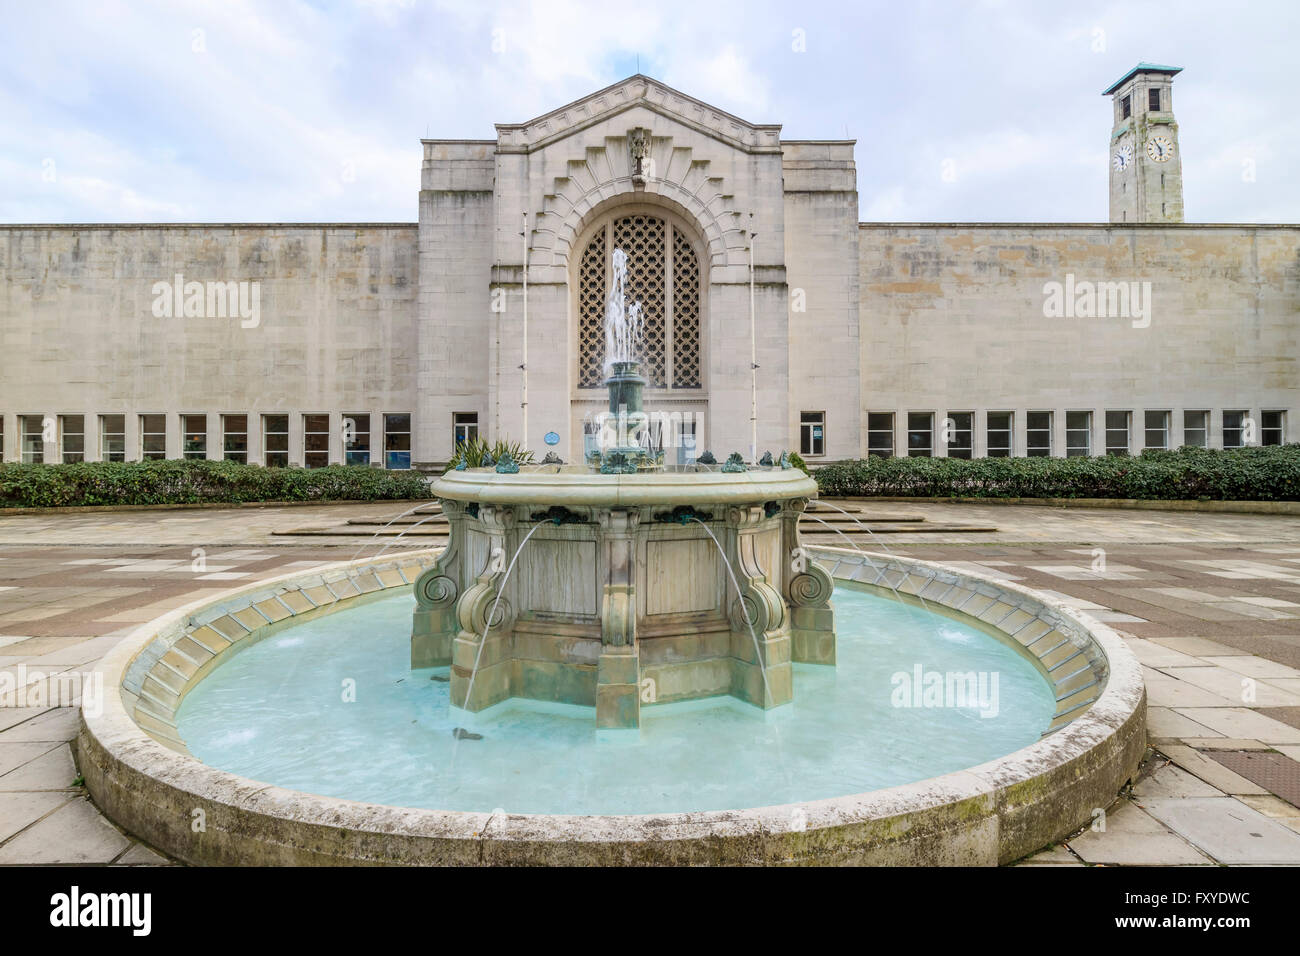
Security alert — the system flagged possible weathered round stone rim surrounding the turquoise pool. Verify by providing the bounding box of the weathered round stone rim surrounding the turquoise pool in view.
[77,548,1147,865]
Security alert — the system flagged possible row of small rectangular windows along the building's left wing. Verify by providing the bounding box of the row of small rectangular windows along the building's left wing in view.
[0,412,411,470]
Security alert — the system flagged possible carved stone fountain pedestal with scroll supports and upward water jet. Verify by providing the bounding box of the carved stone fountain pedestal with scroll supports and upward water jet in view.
[411,250,835,730]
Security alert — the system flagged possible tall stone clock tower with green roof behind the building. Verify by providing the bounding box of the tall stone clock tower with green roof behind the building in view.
[1102,62,1183,222]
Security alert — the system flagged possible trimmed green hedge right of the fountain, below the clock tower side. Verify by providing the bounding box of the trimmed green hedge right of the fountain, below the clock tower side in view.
[814,445,1300,501]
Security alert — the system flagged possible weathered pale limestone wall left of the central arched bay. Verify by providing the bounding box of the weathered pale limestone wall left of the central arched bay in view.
[0,224,419,463]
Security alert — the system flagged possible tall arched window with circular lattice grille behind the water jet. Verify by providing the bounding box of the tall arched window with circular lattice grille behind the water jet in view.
[577,213,701,389]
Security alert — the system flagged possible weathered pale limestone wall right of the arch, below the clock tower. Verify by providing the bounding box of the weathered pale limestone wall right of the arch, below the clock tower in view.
[858,224,1300,455]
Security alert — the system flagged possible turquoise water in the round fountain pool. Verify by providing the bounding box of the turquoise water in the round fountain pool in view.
[178,588,1054,814]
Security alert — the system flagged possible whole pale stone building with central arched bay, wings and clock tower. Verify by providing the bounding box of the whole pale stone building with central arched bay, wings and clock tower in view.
[0,70,1300,468]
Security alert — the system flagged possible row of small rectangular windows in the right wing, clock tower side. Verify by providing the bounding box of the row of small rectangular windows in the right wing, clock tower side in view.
[857,410,1286,458]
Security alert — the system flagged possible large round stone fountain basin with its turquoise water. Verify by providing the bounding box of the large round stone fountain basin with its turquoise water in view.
[78,548,1145,864]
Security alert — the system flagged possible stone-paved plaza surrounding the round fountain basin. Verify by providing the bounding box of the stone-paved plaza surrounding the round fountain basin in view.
[0,502,1300,866]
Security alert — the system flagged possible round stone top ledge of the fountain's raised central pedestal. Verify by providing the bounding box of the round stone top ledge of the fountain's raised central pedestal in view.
[432,466,816,507]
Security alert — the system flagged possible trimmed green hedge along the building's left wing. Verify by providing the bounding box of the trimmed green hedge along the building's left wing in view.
[0,459,432,507]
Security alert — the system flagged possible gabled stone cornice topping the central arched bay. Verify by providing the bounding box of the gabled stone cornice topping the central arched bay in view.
[497,73,781,152]
